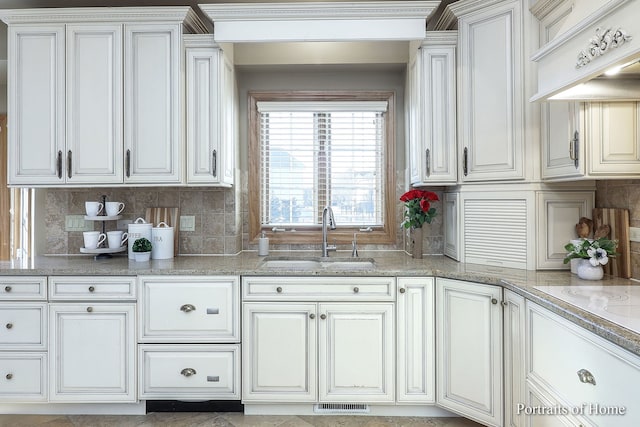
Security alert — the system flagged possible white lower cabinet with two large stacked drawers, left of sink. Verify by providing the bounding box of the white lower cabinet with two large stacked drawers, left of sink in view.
[138,276,240,400]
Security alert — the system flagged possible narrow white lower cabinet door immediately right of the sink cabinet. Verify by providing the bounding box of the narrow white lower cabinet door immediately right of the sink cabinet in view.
[396,277,435,403]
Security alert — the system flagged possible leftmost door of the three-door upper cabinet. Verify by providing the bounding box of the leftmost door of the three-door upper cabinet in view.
[7,25,66,185]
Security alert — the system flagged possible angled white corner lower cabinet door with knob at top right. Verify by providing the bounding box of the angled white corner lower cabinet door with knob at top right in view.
[436,279,503,426]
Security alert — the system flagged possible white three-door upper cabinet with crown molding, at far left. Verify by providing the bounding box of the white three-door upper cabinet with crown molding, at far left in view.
[0,7,204,187]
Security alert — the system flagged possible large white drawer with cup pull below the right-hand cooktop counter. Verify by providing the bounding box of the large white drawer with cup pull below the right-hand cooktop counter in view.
[527,303,640,426]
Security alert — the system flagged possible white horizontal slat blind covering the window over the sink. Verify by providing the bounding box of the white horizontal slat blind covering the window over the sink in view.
[258,101,387,228]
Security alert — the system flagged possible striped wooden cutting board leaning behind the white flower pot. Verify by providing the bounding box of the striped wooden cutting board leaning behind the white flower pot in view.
[593,208,631,279]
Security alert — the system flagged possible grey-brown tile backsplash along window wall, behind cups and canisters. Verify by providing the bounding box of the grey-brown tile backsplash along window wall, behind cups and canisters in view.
[42,173,444,255]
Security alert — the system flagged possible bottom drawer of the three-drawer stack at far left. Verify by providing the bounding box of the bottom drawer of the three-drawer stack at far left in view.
[0,352,47,402]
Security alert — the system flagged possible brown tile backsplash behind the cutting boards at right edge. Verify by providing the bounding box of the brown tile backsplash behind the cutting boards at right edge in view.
[596,179,640,279]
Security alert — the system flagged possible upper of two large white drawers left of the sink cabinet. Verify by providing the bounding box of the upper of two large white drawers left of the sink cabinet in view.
[139,276,240,343]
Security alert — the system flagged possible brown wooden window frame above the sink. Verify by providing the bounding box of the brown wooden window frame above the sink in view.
[247,91,396,244]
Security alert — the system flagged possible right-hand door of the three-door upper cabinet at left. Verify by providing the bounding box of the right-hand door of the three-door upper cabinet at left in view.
[124,24,182,184]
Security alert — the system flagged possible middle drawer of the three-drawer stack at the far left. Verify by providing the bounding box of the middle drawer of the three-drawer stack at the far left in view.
[0,302,47,350]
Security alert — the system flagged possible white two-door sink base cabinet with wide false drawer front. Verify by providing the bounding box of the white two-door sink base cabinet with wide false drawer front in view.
[242,277,395,403]
